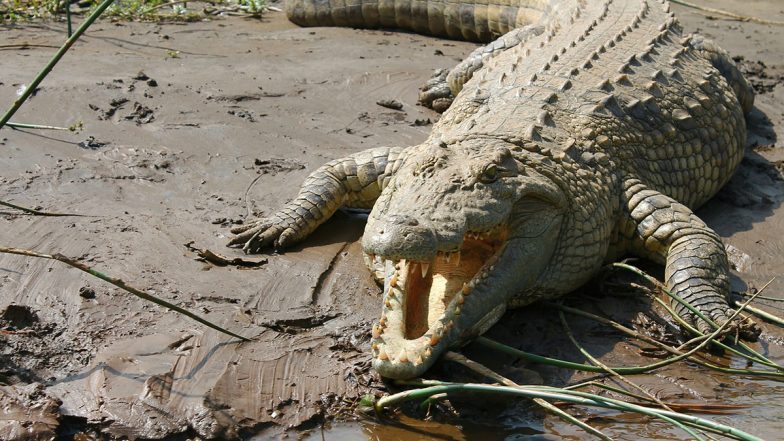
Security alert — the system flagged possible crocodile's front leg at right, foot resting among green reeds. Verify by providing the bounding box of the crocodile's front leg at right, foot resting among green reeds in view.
[620,180,759,339]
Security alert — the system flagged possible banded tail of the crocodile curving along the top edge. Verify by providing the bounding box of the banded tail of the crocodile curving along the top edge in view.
[286,0,548,42]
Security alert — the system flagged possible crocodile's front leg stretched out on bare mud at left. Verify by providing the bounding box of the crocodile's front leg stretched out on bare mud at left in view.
[228,147,405,253]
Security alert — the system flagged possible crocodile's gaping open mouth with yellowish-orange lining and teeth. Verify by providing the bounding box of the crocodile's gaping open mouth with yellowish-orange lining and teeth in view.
[372,225,507,365]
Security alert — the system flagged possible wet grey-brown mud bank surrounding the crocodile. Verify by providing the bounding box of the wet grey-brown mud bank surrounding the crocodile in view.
[0,0,784,439]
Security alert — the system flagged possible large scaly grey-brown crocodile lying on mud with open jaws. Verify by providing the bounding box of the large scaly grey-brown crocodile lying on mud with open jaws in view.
[229,0,758,378]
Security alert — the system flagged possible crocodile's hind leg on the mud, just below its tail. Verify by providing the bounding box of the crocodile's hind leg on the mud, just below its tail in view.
[419,25,544,112]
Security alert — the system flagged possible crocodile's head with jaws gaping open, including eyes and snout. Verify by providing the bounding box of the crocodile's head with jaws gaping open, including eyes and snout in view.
[362,139,566,378]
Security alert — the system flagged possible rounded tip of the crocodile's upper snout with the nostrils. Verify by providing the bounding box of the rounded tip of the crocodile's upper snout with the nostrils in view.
[363,215,438,260]
